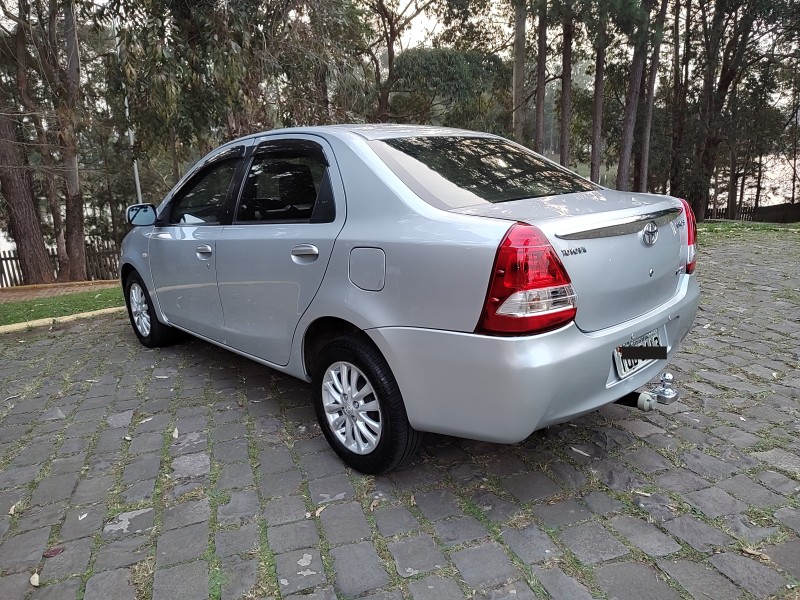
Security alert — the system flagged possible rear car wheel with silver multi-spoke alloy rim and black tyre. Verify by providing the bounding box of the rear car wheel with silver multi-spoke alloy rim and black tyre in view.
[312,336,422,475]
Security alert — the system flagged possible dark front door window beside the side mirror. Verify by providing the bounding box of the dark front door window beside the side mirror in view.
[169,158,240,225]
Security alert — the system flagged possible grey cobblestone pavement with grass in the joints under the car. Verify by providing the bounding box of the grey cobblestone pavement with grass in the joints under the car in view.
[0,227,800,600]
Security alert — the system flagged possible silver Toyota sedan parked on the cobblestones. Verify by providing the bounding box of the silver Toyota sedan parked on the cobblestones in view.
[121,125,699,473]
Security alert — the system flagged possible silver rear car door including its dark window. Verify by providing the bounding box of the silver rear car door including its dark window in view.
[217,136,345,365]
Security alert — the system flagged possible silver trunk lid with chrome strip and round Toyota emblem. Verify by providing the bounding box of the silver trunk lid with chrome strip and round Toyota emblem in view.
[456,190,685,332]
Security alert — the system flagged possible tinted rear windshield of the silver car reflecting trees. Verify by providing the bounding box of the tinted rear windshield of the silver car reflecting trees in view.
[371,136,599,209]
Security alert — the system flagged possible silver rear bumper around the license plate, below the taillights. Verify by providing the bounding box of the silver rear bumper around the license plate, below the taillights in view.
[367,276,699,443]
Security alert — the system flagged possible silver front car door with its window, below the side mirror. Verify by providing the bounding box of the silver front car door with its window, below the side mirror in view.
[148,147,244,341]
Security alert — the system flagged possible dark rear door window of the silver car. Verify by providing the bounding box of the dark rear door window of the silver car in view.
[236,140,333,223]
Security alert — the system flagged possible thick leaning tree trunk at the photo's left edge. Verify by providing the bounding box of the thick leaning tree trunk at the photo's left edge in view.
[0,110,54,284]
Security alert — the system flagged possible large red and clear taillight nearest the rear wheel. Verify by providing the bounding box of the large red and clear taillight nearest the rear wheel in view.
[476,223,577,335]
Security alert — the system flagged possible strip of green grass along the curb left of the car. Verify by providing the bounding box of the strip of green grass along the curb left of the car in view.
[0,287,125,325]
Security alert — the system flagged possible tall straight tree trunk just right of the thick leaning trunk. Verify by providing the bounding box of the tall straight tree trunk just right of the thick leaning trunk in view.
[58,1,87,281]
